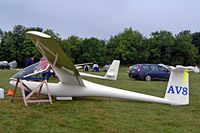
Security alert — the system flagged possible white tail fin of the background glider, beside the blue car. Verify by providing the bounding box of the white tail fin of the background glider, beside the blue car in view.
[104,60,120,80]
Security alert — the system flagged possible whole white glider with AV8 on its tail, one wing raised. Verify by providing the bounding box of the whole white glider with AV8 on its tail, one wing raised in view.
[10,31,189,105]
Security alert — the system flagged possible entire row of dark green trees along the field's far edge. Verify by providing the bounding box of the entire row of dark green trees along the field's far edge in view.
[0,25,200,67]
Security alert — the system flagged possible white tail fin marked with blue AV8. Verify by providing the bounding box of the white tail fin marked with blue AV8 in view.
[165,67,189,105]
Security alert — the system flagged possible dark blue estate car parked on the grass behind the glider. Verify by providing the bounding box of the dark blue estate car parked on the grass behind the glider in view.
[129,64,170,81]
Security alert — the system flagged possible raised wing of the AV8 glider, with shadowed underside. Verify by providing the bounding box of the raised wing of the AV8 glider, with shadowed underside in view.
[27,31,84,86]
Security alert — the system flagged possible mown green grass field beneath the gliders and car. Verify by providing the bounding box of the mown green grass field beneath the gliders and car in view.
[0,68,200,133]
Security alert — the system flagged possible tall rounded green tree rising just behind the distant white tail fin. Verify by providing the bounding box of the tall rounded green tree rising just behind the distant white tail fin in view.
[106,28,147,64]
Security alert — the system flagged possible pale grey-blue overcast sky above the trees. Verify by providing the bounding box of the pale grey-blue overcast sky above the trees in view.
[0,0,200,39]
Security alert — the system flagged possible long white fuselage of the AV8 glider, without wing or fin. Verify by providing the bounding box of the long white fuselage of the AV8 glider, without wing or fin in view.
[11,80,173,104]
